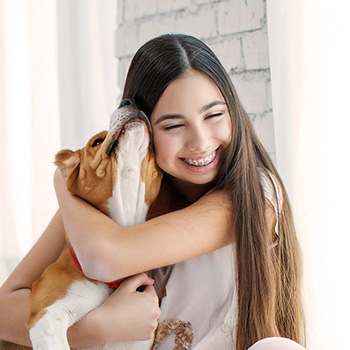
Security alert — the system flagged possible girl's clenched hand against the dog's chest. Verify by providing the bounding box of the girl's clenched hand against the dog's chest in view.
[92,273,160,343]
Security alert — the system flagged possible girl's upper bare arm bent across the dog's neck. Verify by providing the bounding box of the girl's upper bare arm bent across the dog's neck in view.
[55,171,235,282]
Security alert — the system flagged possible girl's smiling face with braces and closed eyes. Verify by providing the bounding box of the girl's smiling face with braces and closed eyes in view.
[151,70,232,190]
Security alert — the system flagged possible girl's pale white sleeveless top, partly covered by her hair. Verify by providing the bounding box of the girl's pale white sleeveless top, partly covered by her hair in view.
[155,174,282,350]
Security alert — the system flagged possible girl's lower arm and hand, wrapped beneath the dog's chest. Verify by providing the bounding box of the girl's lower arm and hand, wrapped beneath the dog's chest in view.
[0,212,160,348]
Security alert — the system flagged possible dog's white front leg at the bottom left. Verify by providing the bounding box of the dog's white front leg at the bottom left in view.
[29,280,110,350]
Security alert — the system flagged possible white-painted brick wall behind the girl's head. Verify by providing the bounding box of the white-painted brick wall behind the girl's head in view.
[115,0,275,159]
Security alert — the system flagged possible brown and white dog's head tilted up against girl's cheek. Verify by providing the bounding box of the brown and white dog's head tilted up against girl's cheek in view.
[55,100,162,222]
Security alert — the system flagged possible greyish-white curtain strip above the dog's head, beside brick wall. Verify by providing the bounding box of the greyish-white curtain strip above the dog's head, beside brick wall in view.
[56,0,120,149]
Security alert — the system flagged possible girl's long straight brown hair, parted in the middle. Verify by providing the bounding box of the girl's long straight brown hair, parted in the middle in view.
[123,34,305,350]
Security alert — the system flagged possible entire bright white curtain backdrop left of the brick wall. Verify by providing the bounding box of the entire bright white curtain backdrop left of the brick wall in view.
[0,0,119,283]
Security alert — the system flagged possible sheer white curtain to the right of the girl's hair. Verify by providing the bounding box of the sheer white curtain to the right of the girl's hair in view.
[267,0,350,350]
